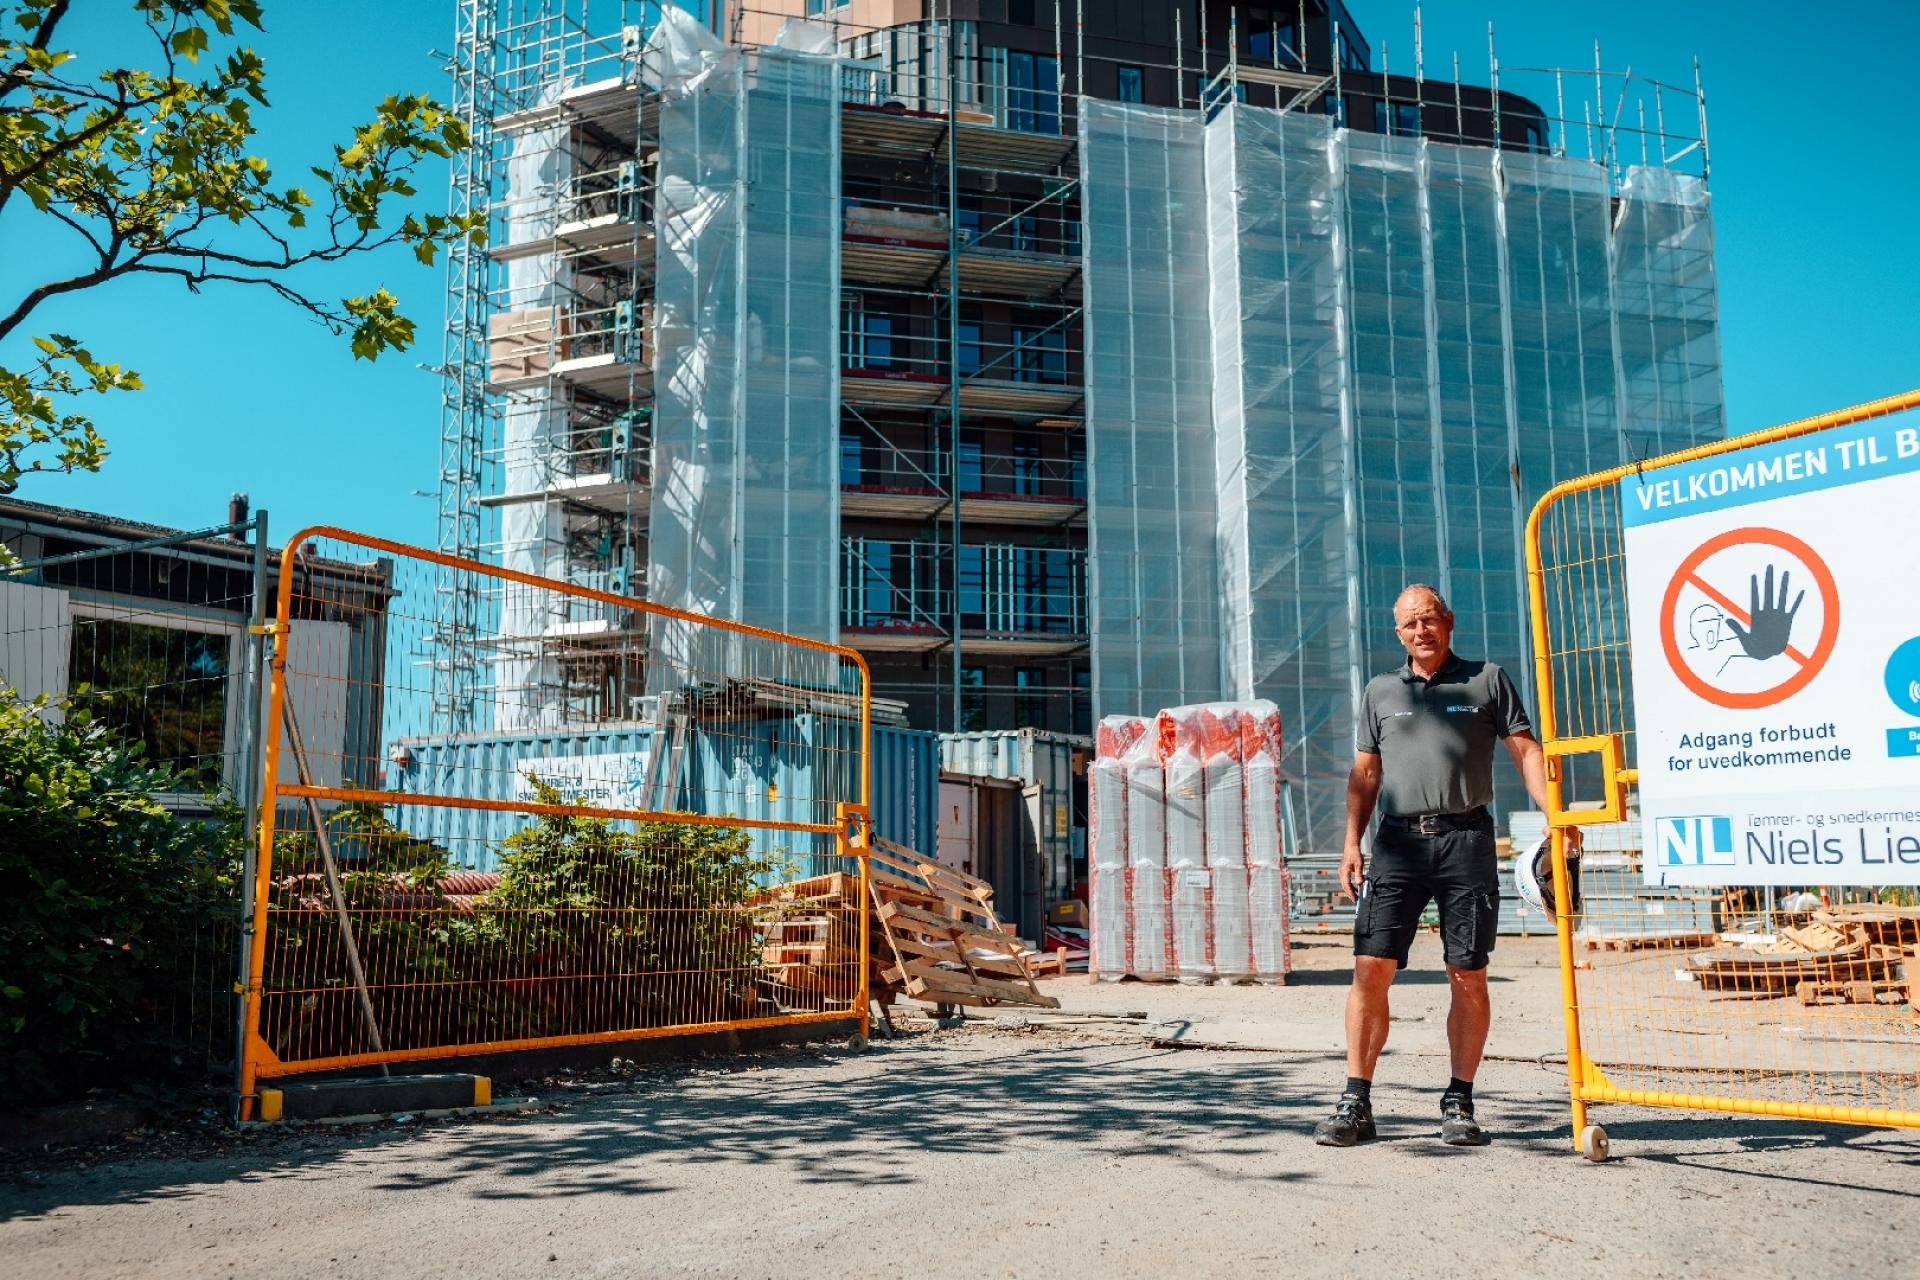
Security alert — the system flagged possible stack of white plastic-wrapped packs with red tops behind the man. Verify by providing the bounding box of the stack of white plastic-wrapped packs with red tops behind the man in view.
[1087,702,1292,983]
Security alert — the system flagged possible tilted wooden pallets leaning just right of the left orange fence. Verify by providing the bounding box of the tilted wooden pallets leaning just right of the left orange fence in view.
[868,839,1060,1009]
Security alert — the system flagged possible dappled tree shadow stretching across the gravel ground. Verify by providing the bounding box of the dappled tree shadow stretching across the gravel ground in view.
[0,1034,1920,1221]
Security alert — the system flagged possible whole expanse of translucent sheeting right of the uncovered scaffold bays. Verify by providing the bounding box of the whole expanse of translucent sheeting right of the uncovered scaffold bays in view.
[1081,102,1726,859]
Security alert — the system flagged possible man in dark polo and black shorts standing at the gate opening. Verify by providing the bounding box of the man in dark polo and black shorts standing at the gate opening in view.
[1313,583,1580,1148]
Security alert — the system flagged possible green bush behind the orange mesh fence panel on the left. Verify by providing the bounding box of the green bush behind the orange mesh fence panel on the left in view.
[261,783,783,1059]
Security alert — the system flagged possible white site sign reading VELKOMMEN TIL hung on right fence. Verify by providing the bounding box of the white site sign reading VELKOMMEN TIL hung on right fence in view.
[1620,415,1920,887]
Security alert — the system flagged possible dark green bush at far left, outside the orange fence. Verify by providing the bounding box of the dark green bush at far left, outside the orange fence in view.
[0,689,242,1103]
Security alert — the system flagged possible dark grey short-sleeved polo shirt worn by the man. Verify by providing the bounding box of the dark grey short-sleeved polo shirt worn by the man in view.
[1354,654,1534,818]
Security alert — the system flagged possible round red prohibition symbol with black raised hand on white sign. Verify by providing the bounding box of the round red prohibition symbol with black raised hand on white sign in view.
[1661,528,1839,710]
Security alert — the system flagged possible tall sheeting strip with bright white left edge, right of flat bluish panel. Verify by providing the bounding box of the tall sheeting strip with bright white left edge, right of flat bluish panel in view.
[1206,109,1357,844]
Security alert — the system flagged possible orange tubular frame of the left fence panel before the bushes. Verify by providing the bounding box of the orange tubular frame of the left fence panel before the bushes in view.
[240,524,874,1121]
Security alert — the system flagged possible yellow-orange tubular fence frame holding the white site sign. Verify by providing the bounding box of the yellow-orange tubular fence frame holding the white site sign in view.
[1526,388,1920,1151]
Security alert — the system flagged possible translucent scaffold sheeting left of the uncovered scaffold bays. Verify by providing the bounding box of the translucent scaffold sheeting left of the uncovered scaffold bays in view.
[649,50,841,662]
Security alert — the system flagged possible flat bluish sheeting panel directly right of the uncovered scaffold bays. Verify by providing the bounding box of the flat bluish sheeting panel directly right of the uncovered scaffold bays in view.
[1081,100,1221,710]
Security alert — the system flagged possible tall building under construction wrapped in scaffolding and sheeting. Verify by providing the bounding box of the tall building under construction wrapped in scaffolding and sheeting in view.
[436,0,1726,848]
